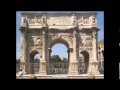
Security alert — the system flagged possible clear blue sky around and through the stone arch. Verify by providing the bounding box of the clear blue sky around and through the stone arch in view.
[16,12,104,59]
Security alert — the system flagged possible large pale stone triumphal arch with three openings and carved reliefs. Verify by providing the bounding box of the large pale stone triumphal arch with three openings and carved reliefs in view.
[20,12,99,75]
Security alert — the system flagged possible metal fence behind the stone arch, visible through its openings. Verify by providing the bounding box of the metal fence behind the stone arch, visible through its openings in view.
[16,63,104,74]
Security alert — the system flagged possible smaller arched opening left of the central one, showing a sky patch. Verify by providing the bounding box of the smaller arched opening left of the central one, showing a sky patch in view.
[30,51,41,74]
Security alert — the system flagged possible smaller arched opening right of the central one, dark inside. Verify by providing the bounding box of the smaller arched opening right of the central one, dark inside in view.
[80,51,89,74]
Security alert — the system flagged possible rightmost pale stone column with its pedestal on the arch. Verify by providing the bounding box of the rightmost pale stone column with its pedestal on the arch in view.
[92,30,100,74]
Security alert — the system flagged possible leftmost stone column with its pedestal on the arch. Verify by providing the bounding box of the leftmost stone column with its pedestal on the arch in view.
[20,31,26,74]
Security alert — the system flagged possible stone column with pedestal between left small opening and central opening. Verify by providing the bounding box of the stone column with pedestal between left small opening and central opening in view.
[39,30,47,75]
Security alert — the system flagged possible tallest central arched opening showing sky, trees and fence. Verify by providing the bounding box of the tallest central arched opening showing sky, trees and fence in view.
[49,38,69,74]
